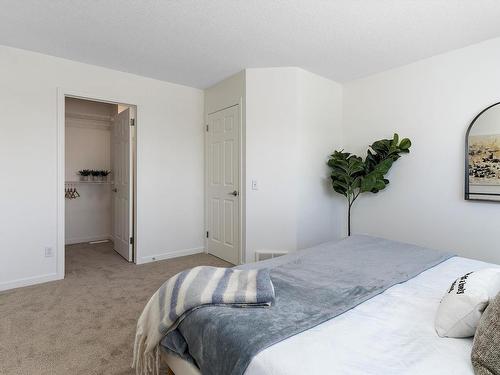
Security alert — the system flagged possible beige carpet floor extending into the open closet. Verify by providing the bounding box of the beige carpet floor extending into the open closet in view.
[0,244,230,375]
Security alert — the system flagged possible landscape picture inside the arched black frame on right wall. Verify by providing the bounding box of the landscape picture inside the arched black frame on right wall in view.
[469,134,500,186]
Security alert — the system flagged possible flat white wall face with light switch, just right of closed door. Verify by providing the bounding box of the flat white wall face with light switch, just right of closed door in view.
[246,68,299,261]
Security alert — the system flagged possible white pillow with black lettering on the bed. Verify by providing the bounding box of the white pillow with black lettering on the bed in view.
[435,268,500,337]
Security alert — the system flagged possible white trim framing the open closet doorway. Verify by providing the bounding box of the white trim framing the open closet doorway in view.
[55,87,139,279]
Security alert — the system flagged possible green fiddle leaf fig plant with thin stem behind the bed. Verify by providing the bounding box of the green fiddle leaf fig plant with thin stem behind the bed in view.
[327,134,411,236]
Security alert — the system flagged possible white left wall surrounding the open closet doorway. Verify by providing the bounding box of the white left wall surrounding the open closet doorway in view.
[0,47,203,289]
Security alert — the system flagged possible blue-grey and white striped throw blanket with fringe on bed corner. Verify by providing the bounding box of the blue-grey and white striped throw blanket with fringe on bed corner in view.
[132,266,274,375]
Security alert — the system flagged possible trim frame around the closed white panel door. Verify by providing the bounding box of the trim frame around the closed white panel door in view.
[203,97,246,264]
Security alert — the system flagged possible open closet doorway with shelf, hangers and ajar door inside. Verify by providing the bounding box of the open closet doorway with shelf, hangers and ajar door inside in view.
[64,96,136,262]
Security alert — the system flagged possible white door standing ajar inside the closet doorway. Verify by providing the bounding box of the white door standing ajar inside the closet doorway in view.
[111,109,132,262]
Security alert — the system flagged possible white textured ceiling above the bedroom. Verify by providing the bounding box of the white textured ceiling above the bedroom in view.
[0,0,500,88]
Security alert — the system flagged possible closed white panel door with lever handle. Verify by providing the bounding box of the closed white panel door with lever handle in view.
[206,106,240,264]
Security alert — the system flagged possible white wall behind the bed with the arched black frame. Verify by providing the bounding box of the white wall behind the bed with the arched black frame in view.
[343,39,500,263]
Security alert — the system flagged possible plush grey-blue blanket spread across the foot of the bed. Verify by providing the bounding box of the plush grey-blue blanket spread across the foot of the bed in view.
[162,236,452,375]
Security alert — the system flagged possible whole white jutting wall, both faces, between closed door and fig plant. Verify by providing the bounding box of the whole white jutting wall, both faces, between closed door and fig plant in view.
[246,68,342,261]
